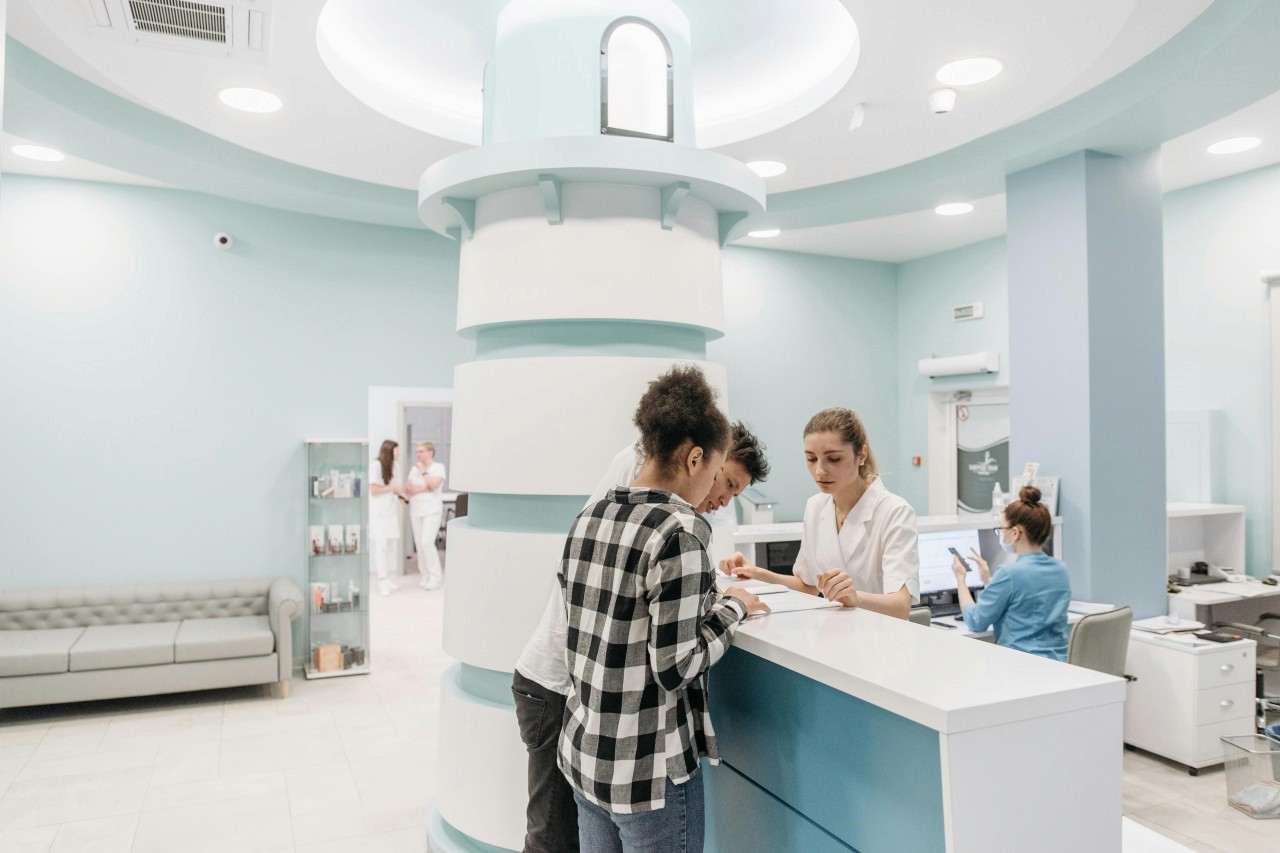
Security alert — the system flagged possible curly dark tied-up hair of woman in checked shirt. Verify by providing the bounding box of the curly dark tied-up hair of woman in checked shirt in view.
[632,365,730,471]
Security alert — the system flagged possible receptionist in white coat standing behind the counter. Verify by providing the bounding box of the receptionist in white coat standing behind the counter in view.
[719,409,920,619]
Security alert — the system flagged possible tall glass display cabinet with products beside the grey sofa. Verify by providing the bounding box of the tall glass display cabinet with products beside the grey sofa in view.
[303,438,371,679]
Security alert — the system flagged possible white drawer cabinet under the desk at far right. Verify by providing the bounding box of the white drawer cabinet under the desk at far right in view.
[1124,630,1257,774]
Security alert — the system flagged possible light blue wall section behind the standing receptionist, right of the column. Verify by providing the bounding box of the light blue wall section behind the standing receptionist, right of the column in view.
[707,247,905,521]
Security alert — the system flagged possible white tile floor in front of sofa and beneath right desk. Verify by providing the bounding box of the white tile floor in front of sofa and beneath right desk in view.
[0,575,1280,853]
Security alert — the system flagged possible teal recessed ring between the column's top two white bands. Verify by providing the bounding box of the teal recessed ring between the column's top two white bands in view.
[475,320,707,361]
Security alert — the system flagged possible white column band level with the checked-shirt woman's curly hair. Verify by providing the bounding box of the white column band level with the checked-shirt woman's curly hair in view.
[449,356,728,494]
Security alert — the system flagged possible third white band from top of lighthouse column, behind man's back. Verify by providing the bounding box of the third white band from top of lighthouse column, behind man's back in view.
[444,519,564,672]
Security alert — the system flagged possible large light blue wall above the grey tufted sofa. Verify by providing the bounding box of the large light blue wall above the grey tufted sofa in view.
[0,175,472,588]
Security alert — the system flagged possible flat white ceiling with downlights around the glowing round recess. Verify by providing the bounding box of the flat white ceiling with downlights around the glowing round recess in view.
[10,0,1280,263]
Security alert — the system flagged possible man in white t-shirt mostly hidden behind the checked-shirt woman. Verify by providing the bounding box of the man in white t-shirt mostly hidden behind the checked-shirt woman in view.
[511,412,769,853]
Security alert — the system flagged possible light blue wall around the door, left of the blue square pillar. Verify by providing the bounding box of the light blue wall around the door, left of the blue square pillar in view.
[896,238,1009,515]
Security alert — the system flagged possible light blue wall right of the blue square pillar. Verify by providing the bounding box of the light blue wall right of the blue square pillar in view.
[1165,167,1280,575]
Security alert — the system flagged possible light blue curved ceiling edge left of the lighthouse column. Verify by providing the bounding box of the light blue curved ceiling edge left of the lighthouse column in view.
[4,37,422,229]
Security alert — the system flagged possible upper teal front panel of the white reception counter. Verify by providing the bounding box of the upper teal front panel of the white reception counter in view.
[708,649,946,853]
